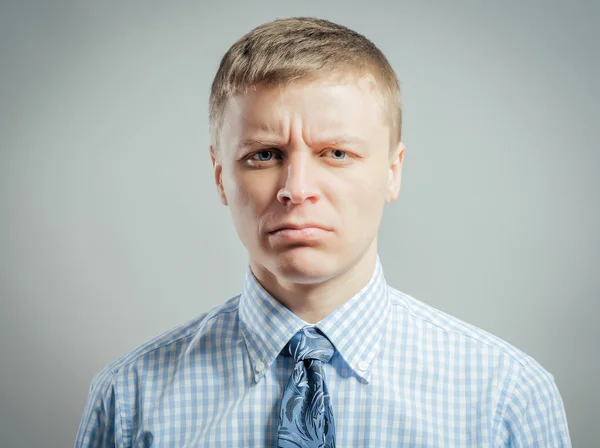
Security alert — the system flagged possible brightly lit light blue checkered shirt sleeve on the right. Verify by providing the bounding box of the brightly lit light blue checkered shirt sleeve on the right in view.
[501,361,571,448]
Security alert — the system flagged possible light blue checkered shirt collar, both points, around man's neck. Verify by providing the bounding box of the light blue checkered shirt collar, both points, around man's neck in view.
[239,256,391,383]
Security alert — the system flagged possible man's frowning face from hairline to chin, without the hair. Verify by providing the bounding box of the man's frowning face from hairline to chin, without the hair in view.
[211,76,404,283]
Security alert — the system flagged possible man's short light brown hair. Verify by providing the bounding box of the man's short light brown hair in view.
[209,17,402,151]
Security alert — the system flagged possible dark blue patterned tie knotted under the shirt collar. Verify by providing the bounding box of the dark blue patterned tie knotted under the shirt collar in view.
[277,327,335,448]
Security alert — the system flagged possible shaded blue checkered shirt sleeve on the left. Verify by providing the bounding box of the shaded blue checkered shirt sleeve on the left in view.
[75,369,122,448]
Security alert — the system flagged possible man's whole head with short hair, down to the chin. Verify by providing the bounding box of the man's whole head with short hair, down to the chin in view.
[210,18,404,284]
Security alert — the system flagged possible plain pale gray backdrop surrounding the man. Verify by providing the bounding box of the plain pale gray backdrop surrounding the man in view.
[0,0,600,447]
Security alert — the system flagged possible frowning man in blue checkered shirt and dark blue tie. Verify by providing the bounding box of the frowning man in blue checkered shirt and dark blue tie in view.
[75,18,570,447]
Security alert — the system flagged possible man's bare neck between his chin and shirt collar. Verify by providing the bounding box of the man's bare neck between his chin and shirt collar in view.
[250,245,377,324]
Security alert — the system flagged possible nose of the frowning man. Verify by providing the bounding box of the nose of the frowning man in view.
[277,151,319,205]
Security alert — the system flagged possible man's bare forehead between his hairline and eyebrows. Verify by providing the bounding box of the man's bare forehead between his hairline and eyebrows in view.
[223,75,387,140]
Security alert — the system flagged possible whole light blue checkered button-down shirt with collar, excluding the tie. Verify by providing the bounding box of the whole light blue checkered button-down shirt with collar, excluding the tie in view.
[75,258,571,448]
